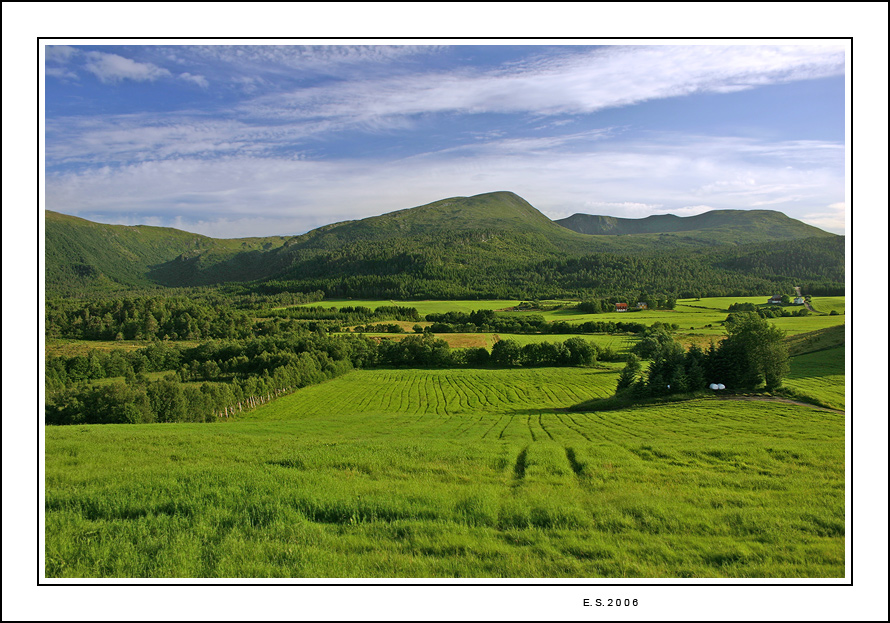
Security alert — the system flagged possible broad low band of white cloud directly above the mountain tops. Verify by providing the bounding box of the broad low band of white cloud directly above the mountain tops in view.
[47,132,844,237]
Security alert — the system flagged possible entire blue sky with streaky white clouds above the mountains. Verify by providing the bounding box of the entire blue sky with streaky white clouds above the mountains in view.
[45,40,845,237]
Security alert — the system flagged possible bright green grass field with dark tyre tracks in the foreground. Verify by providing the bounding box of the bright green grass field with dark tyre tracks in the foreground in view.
[45,368,845,578]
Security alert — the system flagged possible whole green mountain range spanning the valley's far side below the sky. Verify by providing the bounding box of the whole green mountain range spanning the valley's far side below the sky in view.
[45,192,844,299]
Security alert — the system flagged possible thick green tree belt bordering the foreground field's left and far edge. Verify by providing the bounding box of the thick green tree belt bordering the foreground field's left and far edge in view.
[45,333,600,424]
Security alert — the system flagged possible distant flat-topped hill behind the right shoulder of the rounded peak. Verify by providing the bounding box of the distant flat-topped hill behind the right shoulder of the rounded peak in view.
[554,210,833,242]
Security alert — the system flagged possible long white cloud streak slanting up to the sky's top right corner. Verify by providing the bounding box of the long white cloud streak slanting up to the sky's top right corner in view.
[239,46,844,124]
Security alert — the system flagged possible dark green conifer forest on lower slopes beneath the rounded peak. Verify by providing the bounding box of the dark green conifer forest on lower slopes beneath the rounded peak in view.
[238,237,845,302]
